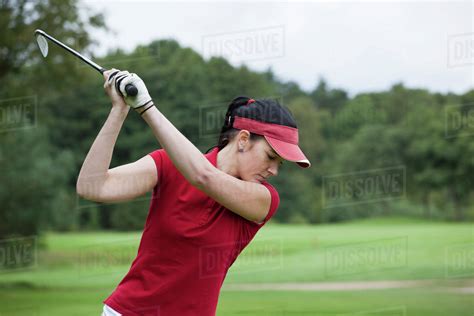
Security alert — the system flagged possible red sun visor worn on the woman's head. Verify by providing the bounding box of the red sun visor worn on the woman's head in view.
[233,116,311,168]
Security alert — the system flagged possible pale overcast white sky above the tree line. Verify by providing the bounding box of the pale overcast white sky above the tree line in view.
[85,0,474,94]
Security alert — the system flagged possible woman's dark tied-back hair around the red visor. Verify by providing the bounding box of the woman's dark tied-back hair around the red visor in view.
[217,96,296,150]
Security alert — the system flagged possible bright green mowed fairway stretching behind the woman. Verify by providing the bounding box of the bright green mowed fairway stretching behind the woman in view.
[0,219,474,316]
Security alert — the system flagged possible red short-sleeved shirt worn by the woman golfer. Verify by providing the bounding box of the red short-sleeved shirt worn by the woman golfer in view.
[104,148,280,316]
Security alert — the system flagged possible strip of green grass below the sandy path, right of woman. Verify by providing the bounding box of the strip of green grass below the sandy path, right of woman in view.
[217,289,474,316]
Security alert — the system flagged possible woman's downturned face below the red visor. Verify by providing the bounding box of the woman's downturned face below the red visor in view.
[238,137,284,183]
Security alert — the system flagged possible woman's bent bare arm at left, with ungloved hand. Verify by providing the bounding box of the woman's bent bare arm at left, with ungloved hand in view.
[76,71,158,202]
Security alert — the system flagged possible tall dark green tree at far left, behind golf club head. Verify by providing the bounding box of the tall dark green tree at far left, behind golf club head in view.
[0,0,104,238]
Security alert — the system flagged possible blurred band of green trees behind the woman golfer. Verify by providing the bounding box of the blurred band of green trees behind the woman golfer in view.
[0,0,474,238]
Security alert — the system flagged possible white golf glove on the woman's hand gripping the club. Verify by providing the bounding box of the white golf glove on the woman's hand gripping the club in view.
[112,71,154,114]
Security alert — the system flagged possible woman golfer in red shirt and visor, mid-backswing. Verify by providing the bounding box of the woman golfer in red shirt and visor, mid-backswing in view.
[77,69,310,316]
